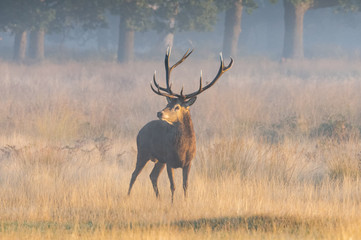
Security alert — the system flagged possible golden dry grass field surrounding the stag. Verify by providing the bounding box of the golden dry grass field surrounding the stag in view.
[0,57,361,240]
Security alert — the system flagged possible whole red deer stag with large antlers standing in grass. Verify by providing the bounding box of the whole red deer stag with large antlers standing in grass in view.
[128,48,233,202]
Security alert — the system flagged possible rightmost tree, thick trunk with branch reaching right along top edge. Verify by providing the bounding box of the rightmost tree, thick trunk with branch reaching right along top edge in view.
[283,0,340,58]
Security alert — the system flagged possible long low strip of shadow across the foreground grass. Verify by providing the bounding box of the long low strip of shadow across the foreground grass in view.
[0,215,338,233]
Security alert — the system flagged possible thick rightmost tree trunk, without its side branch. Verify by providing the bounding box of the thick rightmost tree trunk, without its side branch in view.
[283,0,310,59]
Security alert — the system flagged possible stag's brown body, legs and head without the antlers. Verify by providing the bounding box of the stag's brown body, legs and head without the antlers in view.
[128,99,196,200]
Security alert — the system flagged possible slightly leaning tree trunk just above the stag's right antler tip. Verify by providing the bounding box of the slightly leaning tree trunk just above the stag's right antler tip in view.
[223,0,243,57]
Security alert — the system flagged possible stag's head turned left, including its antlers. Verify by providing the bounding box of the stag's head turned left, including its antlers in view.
[150,47,233,124]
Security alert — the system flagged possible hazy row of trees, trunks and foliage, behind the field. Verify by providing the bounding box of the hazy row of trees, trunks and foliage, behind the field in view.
[0,0,361,62]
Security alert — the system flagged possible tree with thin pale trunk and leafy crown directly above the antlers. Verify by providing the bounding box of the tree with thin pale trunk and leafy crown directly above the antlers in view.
[155,0,217,49]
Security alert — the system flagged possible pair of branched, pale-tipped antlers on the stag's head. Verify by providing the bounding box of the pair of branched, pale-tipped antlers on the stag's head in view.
[150,47,233,100]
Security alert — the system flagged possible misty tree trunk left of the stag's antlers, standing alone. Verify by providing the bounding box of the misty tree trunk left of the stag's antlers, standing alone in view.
[118,17,134,62]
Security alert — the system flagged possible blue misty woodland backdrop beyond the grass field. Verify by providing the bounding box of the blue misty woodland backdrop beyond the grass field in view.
[0,0,361,62]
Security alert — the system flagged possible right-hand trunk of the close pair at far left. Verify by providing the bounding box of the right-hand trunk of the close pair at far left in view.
[29,29,45,61]
